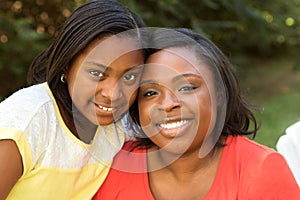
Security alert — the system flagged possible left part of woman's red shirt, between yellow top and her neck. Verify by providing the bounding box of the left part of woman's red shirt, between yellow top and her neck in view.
[93,141,153,200]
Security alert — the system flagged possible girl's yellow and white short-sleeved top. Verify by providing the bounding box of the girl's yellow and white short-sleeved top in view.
[0,83,126,200]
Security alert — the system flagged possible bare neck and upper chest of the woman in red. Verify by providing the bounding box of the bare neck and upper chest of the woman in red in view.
[147,147,223,200]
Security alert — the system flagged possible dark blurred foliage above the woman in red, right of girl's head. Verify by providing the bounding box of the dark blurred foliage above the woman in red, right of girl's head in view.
[120,0,300,56]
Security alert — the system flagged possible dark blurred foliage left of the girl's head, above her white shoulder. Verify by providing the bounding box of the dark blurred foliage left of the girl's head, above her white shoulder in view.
[0,0,81,99]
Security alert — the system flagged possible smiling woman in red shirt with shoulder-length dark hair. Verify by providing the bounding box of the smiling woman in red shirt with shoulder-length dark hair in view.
[94,29,300,200]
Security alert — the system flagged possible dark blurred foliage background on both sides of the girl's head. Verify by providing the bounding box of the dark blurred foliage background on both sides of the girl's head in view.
[0,0,300,99]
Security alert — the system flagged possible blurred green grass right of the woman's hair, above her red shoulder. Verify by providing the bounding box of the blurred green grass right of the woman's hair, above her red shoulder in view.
[238,56,300,149]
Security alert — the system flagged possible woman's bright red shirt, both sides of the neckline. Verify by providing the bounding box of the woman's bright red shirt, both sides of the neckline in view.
[94,136,300,200]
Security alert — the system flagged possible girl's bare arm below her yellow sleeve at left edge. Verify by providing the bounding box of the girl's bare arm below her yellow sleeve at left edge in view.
[0,140,23,200]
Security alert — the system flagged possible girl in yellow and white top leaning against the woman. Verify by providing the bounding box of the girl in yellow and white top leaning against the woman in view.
[0,0,145,200]
